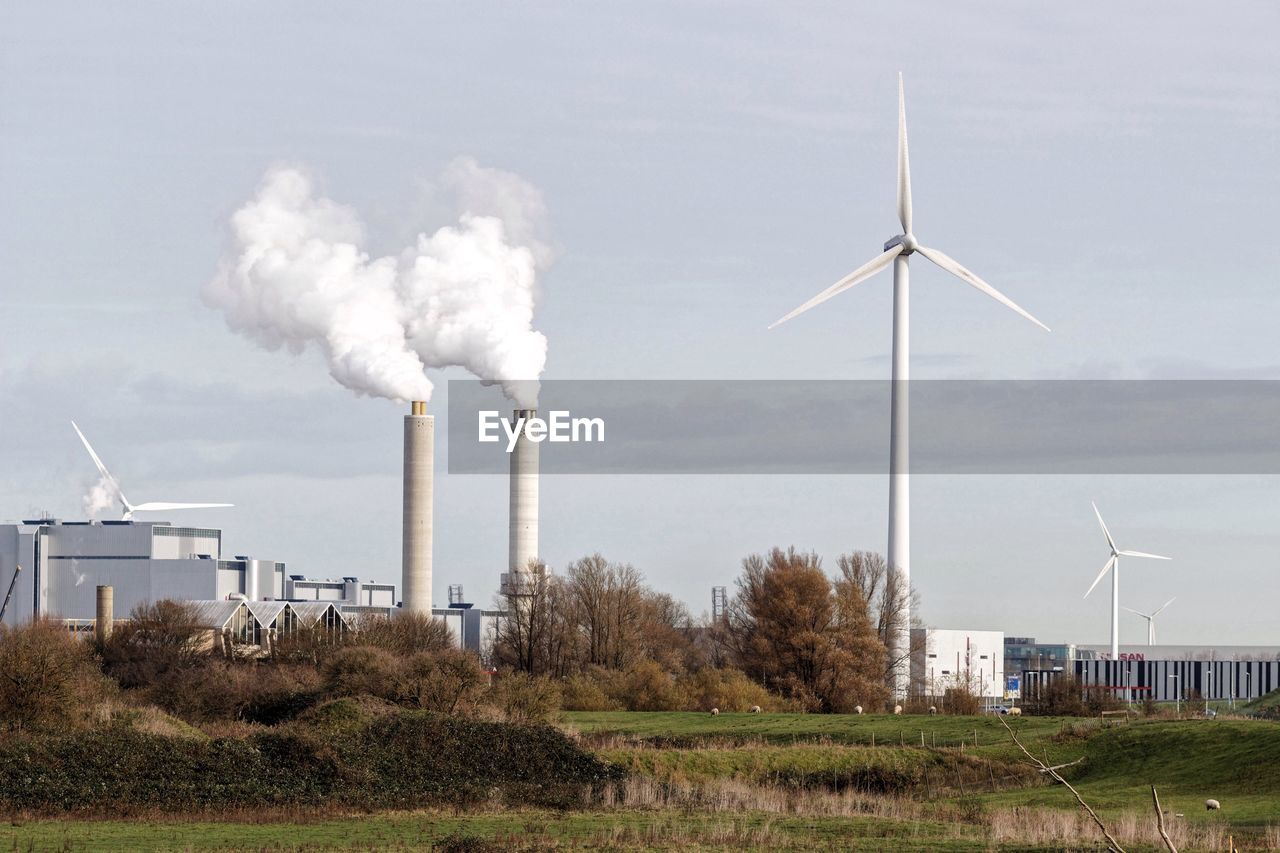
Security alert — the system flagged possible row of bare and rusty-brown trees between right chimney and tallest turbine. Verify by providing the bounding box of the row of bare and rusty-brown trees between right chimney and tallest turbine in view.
[493,547,913,712]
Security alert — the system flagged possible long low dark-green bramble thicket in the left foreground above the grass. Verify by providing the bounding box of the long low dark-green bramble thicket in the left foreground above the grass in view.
[0,699,622,815]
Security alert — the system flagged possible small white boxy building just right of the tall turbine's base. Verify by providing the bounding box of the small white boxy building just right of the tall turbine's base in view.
[911,628,1005,699]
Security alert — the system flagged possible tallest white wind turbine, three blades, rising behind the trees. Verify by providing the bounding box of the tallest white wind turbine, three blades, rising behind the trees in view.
[769,73,1048,695]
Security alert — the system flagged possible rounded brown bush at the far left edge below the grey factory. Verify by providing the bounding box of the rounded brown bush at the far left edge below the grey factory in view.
[0,621,106,731]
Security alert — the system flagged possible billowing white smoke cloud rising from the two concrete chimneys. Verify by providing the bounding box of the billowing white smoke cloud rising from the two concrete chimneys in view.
[204,158,552,406]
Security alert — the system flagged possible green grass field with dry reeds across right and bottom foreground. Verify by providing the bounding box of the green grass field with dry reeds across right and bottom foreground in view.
[0,712,1280,852]
